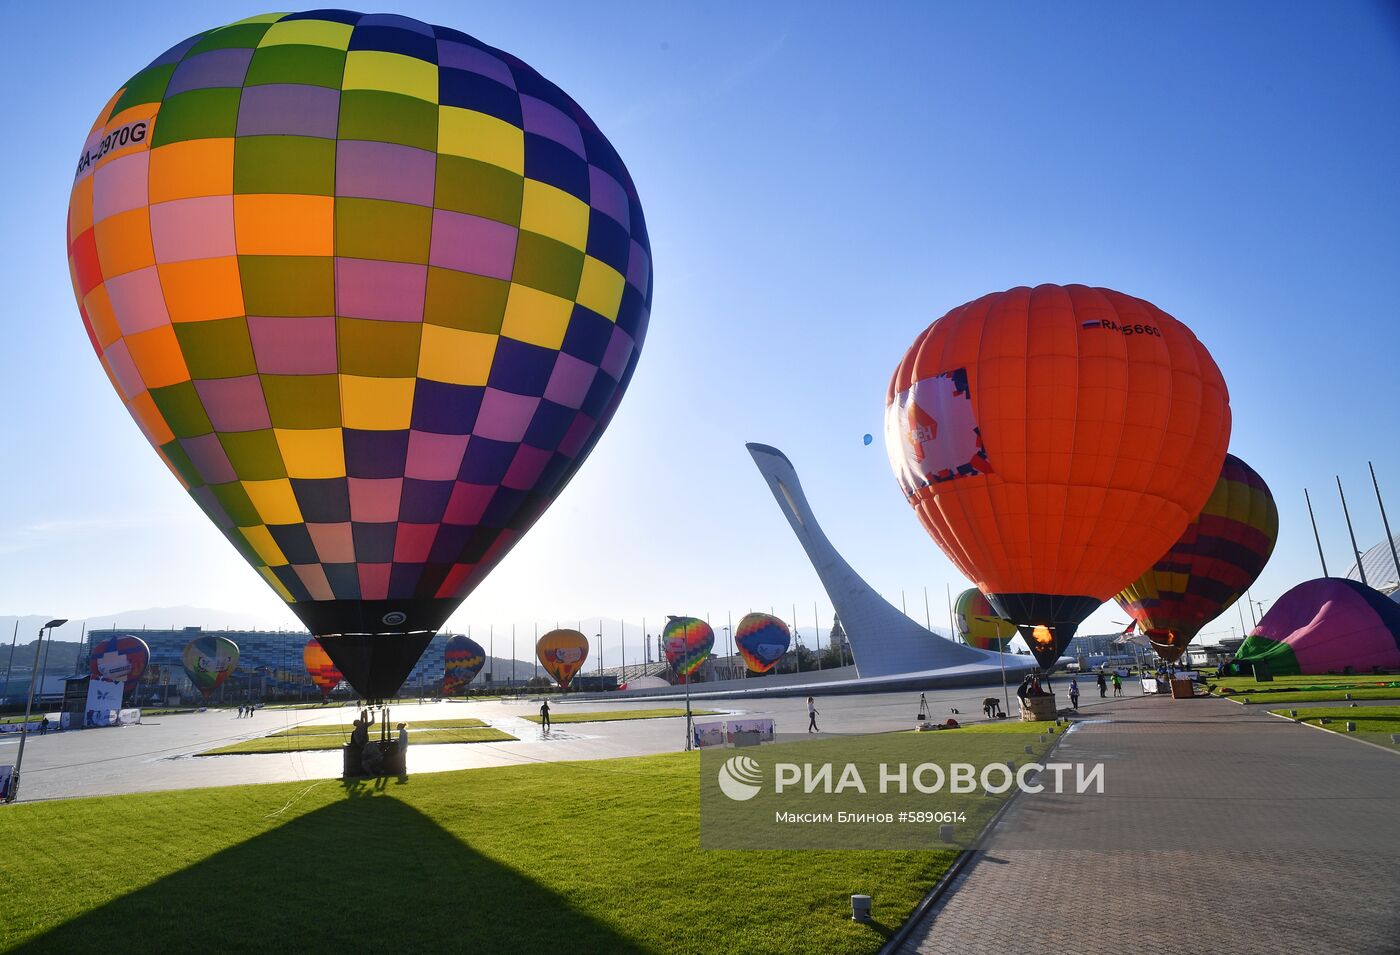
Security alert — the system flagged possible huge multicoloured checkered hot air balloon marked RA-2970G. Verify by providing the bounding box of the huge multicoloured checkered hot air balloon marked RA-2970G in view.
[67,10,651,699]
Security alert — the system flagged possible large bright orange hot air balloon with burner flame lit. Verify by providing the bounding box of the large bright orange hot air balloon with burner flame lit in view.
[885,286,1231,667]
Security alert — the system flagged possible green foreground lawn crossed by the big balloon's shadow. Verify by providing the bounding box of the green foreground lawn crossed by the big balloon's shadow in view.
[0,734,958,955]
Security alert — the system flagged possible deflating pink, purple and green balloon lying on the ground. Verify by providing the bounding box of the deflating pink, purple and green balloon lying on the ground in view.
[1235,577,1400,675]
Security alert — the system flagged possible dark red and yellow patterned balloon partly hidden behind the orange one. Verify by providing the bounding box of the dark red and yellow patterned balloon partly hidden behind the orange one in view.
[1113,454,1278,662]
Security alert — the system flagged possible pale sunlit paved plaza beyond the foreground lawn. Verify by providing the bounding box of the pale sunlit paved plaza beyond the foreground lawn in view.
[0,677,1069,801]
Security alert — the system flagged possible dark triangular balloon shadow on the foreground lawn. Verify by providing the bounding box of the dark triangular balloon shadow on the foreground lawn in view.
[17,784,647,955]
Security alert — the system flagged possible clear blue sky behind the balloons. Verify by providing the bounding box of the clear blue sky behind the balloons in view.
[0,0,1400,646]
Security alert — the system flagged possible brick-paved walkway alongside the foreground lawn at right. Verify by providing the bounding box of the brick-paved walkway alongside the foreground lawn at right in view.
[899,697,1400,955]
